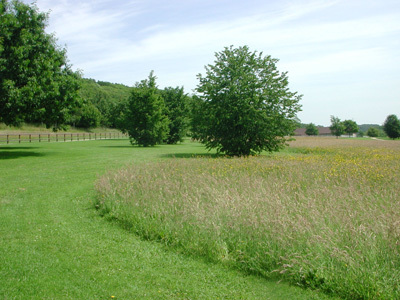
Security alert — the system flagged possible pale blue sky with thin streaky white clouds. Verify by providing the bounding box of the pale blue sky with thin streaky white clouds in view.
[24,0,400,126]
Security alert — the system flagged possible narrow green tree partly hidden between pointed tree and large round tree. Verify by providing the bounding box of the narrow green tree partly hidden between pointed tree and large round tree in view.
[162,87,189,144]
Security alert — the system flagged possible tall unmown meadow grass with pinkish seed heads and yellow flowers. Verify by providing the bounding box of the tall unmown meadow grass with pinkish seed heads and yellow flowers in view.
[96,139,400,299]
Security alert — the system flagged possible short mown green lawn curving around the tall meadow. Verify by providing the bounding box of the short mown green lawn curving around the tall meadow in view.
[0,140,338,299]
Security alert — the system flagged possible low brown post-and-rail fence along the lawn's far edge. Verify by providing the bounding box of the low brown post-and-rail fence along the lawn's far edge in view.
[0,132,128,144]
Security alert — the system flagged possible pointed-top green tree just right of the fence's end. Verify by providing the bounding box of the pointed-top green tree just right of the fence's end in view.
[118,71,169,147]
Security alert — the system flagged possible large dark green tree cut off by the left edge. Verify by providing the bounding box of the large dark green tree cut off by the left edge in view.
[0,0,80,130]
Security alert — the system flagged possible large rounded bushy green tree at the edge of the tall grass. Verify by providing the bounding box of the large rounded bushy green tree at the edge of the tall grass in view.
[194,46,301,156]
